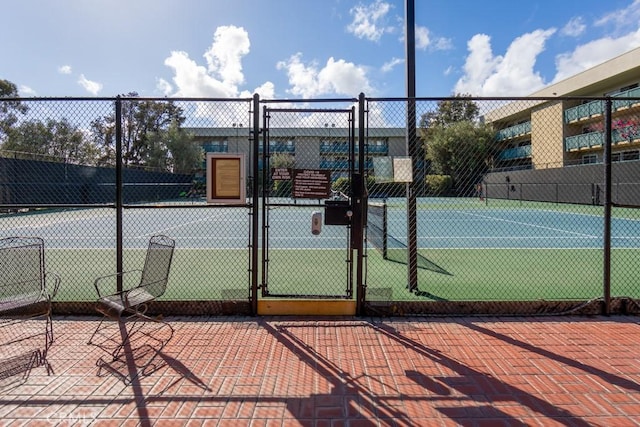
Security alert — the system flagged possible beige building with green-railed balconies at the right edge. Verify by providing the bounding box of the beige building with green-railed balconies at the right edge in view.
[484,48,640,170]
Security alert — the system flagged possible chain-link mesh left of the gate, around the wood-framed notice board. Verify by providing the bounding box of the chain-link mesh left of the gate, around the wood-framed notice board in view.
[0,97,253,314]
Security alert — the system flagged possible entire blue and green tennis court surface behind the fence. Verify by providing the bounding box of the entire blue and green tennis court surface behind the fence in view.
[5,198,640,301]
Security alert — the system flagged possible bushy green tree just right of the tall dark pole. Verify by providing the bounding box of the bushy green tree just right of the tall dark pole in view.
[420,95,495,196]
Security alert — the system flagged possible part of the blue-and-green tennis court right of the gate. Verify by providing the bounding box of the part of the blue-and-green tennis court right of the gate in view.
[368,198,640,301]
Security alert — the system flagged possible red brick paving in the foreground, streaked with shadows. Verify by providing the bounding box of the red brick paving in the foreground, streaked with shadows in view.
[0,316,640,427]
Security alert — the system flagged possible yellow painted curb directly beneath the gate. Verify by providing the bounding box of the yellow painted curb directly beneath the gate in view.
[258,299,356,316]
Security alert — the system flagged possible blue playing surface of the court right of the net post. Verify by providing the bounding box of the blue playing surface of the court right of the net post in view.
[387,208,640,249]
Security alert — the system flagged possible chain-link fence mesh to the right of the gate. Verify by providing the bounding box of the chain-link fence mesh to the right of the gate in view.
[366,97,640,314]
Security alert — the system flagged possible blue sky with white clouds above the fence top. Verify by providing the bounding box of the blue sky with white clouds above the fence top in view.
[0,0,640,99]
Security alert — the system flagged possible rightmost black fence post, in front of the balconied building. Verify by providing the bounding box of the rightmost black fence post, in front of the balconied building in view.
[603,98,611,315]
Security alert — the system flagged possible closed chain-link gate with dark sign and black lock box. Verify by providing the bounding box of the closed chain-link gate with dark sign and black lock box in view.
[259,106,360,299]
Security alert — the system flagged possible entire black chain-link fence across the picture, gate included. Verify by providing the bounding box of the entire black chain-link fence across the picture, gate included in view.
[0,96,640,315]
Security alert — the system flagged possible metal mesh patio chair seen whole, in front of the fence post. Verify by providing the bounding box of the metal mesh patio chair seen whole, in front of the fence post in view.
[89,235,175,359]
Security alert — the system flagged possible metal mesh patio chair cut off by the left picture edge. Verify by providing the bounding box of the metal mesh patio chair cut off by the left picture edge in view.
[0,237,60,378]
